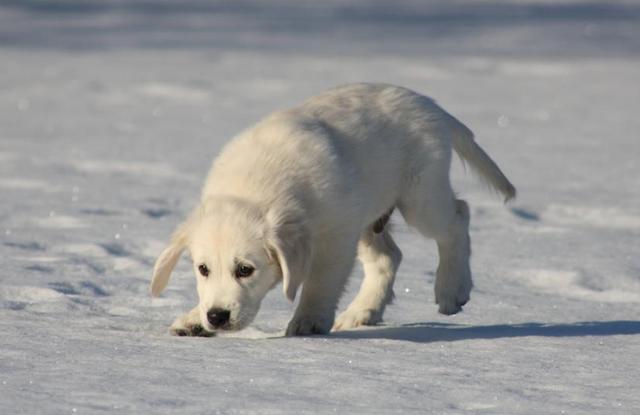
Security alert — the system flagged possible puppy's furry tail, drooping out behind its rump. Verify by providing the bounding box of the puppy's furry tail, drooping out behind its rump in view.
[451,117,516,203]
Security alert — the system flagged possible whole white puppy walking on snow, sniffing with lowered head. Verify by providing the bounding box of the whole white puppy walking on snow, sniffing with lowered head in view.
[151,84,515,335]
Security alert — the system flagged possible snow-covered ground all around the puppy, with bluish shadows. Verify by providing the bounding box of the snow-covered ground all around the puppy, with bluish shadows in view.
[0,0,640,414]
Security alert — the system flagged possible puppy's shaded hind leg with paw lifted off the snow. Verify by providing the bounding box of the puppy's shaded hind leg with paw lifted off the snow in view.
[399,175,473,315]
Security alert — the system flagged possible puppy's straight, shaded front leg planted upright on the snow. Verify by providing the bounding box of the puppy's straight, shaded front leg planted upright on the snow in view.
[286,243,355,336]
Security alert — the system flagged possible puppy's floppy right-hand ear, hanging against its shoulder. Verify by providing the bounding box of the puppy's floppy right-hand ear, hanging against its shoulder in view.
[267,211,311,301]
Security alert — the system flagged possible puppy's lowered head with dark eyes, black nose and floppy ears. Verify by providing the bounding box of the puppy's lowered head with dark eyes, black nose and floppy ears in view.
[151,198,310,331]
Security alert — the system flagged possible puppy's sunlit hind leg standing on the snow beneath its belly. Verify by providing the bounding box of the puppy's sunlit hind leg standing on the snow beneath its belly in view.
[333,228,402,331]
